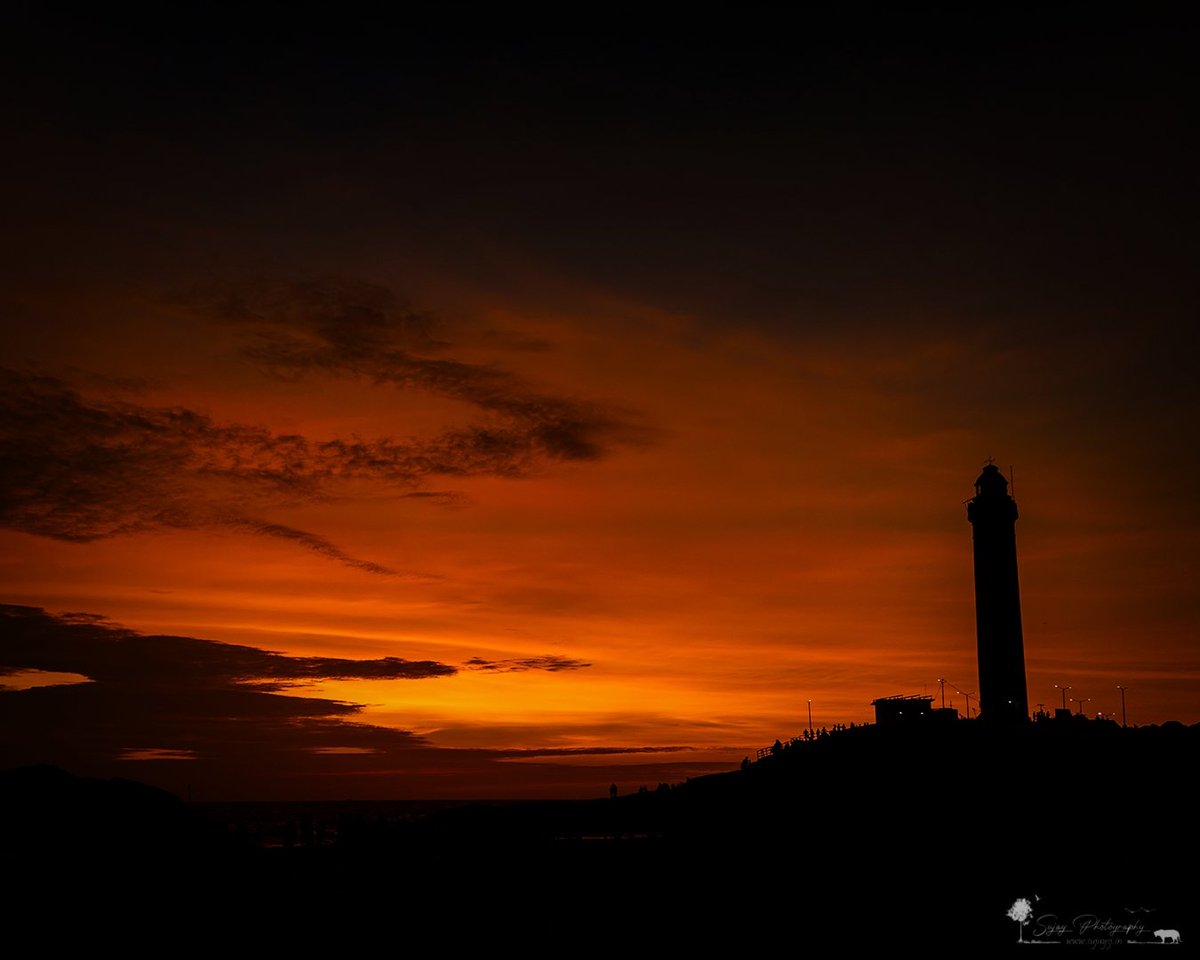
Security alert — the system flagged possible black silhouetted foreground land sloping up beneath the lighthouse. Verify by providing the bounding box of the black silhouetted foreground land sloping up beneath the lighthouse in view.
[0,720,1200,955]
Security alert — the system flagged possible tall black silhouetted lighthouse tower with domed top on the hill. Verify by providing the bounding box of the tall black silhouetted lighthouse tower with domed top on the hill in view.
[967,463,1030,722]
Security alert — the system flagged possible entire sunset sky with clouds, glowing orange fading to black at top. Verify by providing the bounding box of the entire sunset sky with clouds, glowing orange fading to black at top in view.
[0,11,1200,799]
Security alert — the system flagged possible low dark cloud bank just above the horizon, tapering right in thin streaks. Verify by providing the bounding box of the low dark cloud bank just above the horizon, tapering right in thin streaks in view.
[0,605,705,799]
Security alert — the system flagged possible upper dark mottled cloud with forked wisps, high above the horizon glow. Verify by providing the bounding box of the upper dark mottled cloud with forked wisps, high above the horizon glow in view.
[0,314,652,566]
